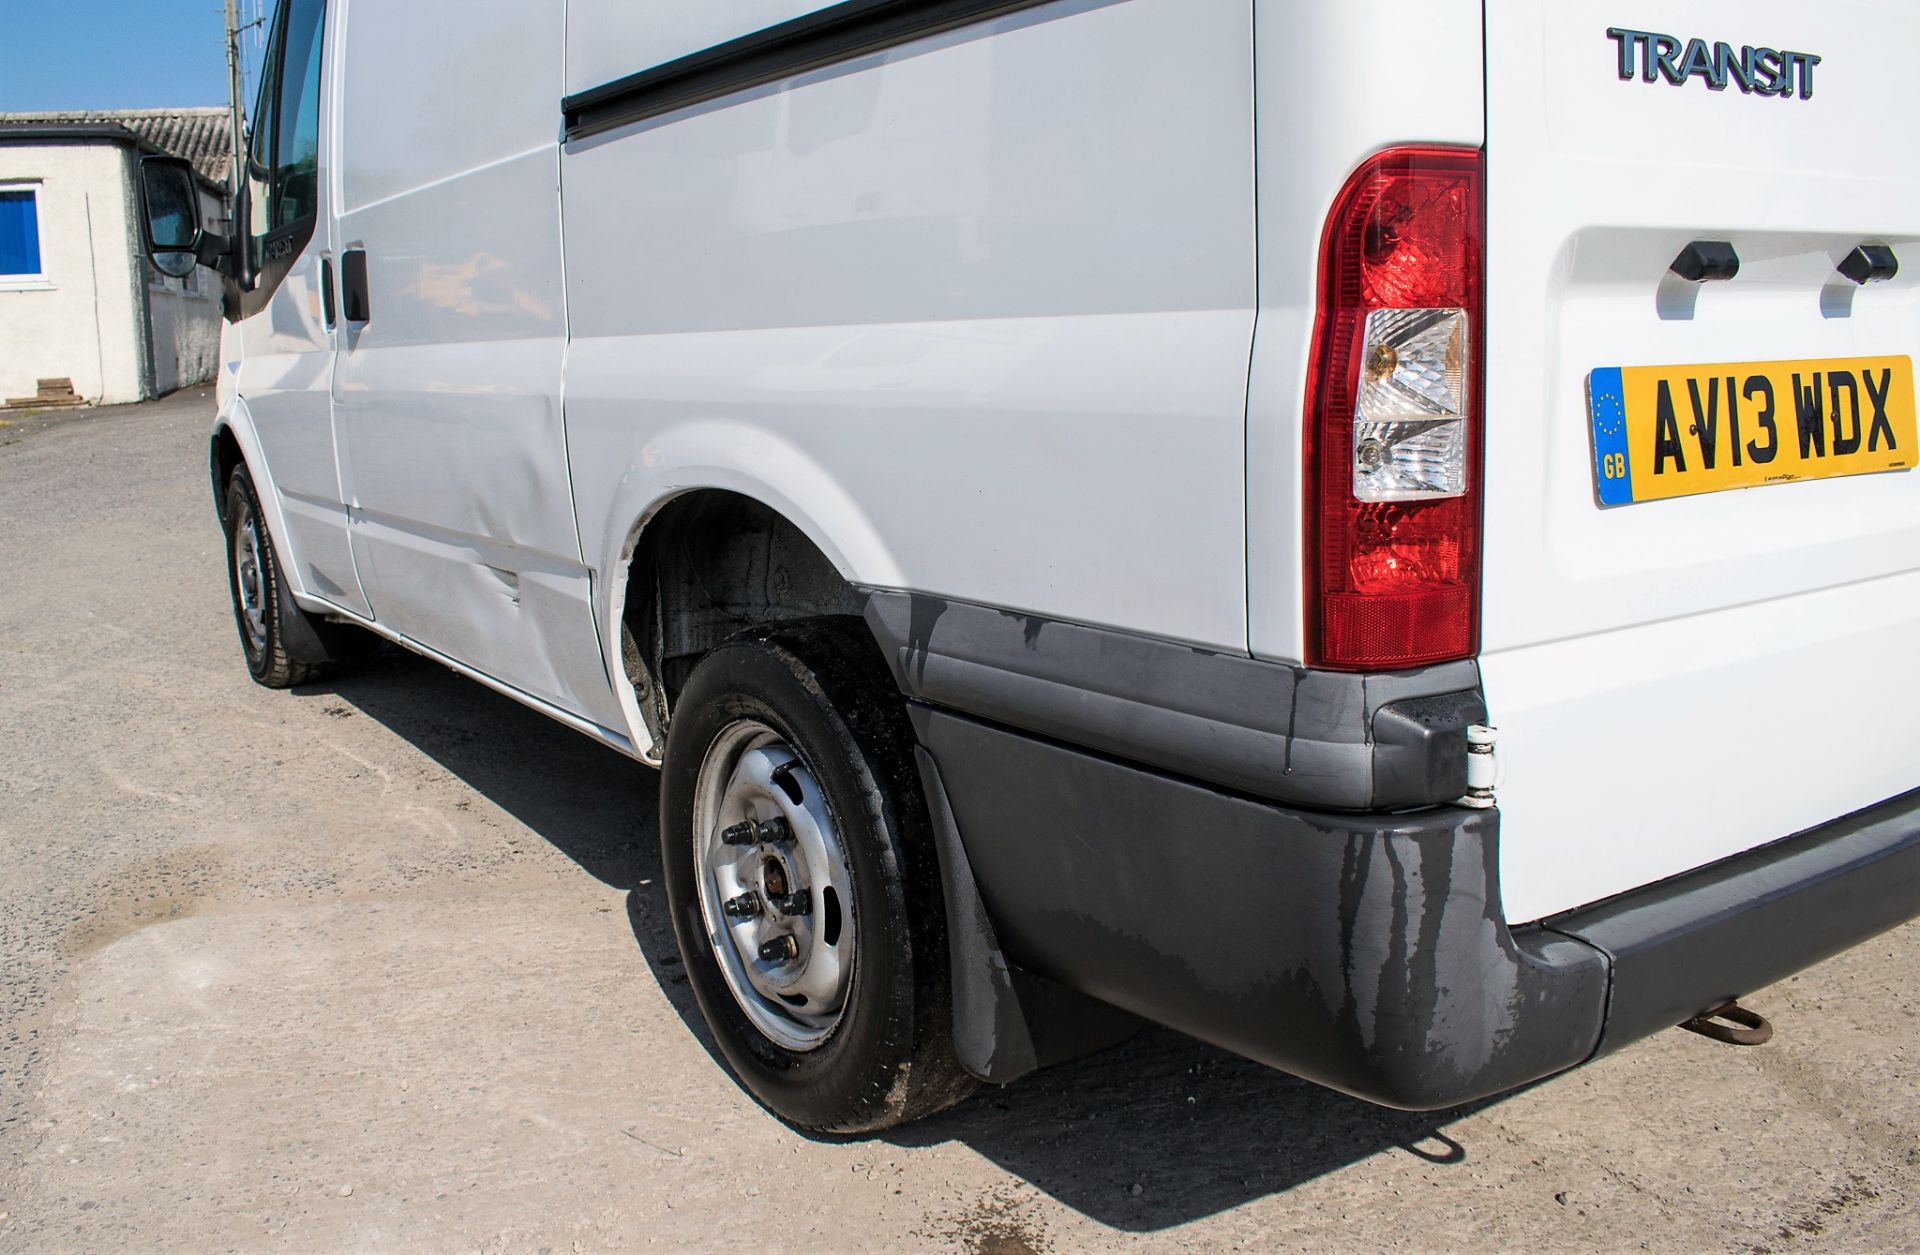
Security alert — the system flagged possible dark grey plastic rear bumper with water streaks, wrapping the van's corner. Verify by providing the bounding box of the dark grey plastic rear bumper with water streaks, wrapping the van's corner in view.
[914,704,1920,1109]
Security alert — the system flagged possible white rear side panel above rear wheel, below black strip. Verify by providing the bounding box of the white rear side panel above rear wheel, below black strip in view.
[564,0,1254,663]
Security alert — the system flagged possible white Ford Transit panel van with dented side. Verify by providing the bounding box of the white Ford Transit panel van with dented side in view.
[146,0,1920,1132]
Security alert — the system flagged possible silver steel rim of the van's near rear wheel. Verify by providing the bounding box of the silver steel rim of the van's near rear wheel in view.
[693,720,854,1052]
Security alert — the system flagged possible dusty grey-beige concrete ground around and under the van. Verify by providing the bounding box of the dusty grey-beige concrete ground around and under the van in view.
[0,391,1920,1255]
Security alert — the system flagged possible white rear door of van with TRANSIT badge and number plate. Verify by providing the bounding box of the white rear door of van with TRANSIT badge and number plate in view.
[1482,0,1920,921]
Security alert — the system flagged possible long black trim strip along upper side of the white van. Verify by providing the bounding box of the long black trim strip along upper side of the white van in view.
[561,0,1048,140]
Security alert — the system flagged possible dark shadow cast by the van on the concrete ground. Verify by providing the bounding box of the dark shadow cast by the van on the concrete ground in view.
[301,652,1486,1232]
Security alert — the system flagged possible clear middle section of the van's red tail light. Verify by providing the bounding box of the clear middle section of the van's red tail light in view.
[1354,309,1469,501]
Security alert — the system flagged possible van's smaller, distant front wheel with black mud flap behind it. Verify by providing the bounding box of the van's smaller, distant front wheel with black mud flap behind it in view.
[225,466,376,689]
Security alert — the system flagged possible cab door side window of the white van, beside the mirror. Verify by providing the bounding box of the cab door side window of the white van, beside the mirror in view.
[248,0,326,269]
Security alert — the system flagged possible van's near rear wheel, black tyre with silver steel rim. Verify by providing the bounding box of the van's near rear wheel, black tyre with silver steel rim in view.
[660,620,973,1134]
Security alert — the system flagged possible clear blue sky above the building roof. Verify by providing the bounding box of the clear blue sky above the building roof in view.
[0,0,252,113]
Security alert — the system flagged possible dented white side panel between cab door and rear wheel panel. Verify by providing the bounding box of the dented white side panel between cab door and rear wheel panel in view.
[334,0,624,725]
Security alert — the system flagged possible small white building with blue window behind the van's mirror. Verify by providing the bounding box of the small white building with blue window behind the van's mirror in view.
[0,109,232,407]
